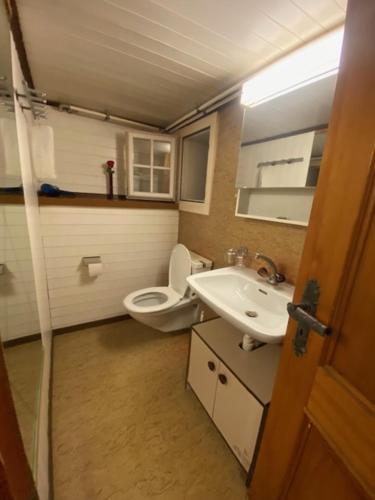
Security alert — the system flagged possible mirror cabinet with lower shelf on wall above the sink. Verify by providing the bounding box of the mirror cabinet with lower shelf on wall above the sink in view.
[236,75,336,226]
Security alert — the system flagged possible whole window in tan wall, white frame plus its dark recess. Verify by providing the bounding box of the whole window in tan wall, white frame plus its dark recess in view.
[179,113,217,215]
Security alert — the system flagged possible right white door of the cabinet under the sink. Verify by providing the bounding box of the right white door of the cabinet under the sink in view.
[213,363,263,470]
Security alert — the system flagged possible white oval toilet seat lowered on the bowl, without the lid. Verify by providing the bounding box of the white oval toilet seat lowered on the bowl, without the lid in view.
[124,286,183,314]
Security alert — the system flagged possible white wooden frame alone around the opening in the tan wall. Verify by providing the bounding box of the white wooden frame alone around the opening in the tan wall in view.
[178,112,218,215]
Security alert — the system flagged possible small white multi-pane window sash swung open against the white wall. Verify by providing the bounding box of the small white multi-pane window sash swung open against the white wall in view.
[128,133,175,200]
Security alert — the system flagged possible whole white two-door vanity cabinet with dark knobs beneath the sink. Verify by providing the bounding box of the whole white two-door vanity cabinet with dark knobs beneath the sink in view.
[187,318,281,471]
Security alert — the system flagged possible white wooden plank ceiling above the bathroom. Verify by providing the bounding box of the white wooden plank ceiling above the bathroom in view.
[17,0,346,126]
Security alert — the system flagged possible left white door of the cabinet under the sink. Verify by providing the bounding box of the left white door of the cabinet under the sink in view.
[188,332,220,416]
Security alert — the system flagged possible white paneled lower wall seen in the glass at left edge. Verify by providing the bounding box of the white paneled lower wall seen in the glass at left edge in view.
[0,205,40,341]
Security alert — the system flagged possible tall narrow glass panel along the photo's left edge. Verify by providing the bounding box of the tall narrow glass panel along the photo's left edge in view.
[0,2,43,469]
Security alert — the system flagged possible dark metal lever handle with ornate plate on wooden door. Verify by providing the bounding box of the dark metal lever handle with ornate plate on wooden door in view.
[287,280,331,356]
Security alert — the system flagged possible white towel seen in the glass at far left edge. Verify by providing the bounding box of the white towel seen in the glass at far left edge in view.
[0,118,21,178]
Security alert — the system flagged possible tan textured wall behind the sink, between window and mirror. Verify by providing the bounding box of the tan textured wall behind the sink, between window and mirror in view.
[179,101,306,283]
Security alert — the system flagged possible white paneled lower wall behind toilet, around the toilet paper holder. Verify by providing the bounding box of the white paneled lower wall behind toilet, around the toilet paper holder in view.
[41,206,178,328]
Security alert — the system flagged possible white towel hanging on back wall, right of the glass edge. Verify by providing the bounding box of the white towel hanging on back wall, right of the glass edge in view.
[31,125,56,179]
